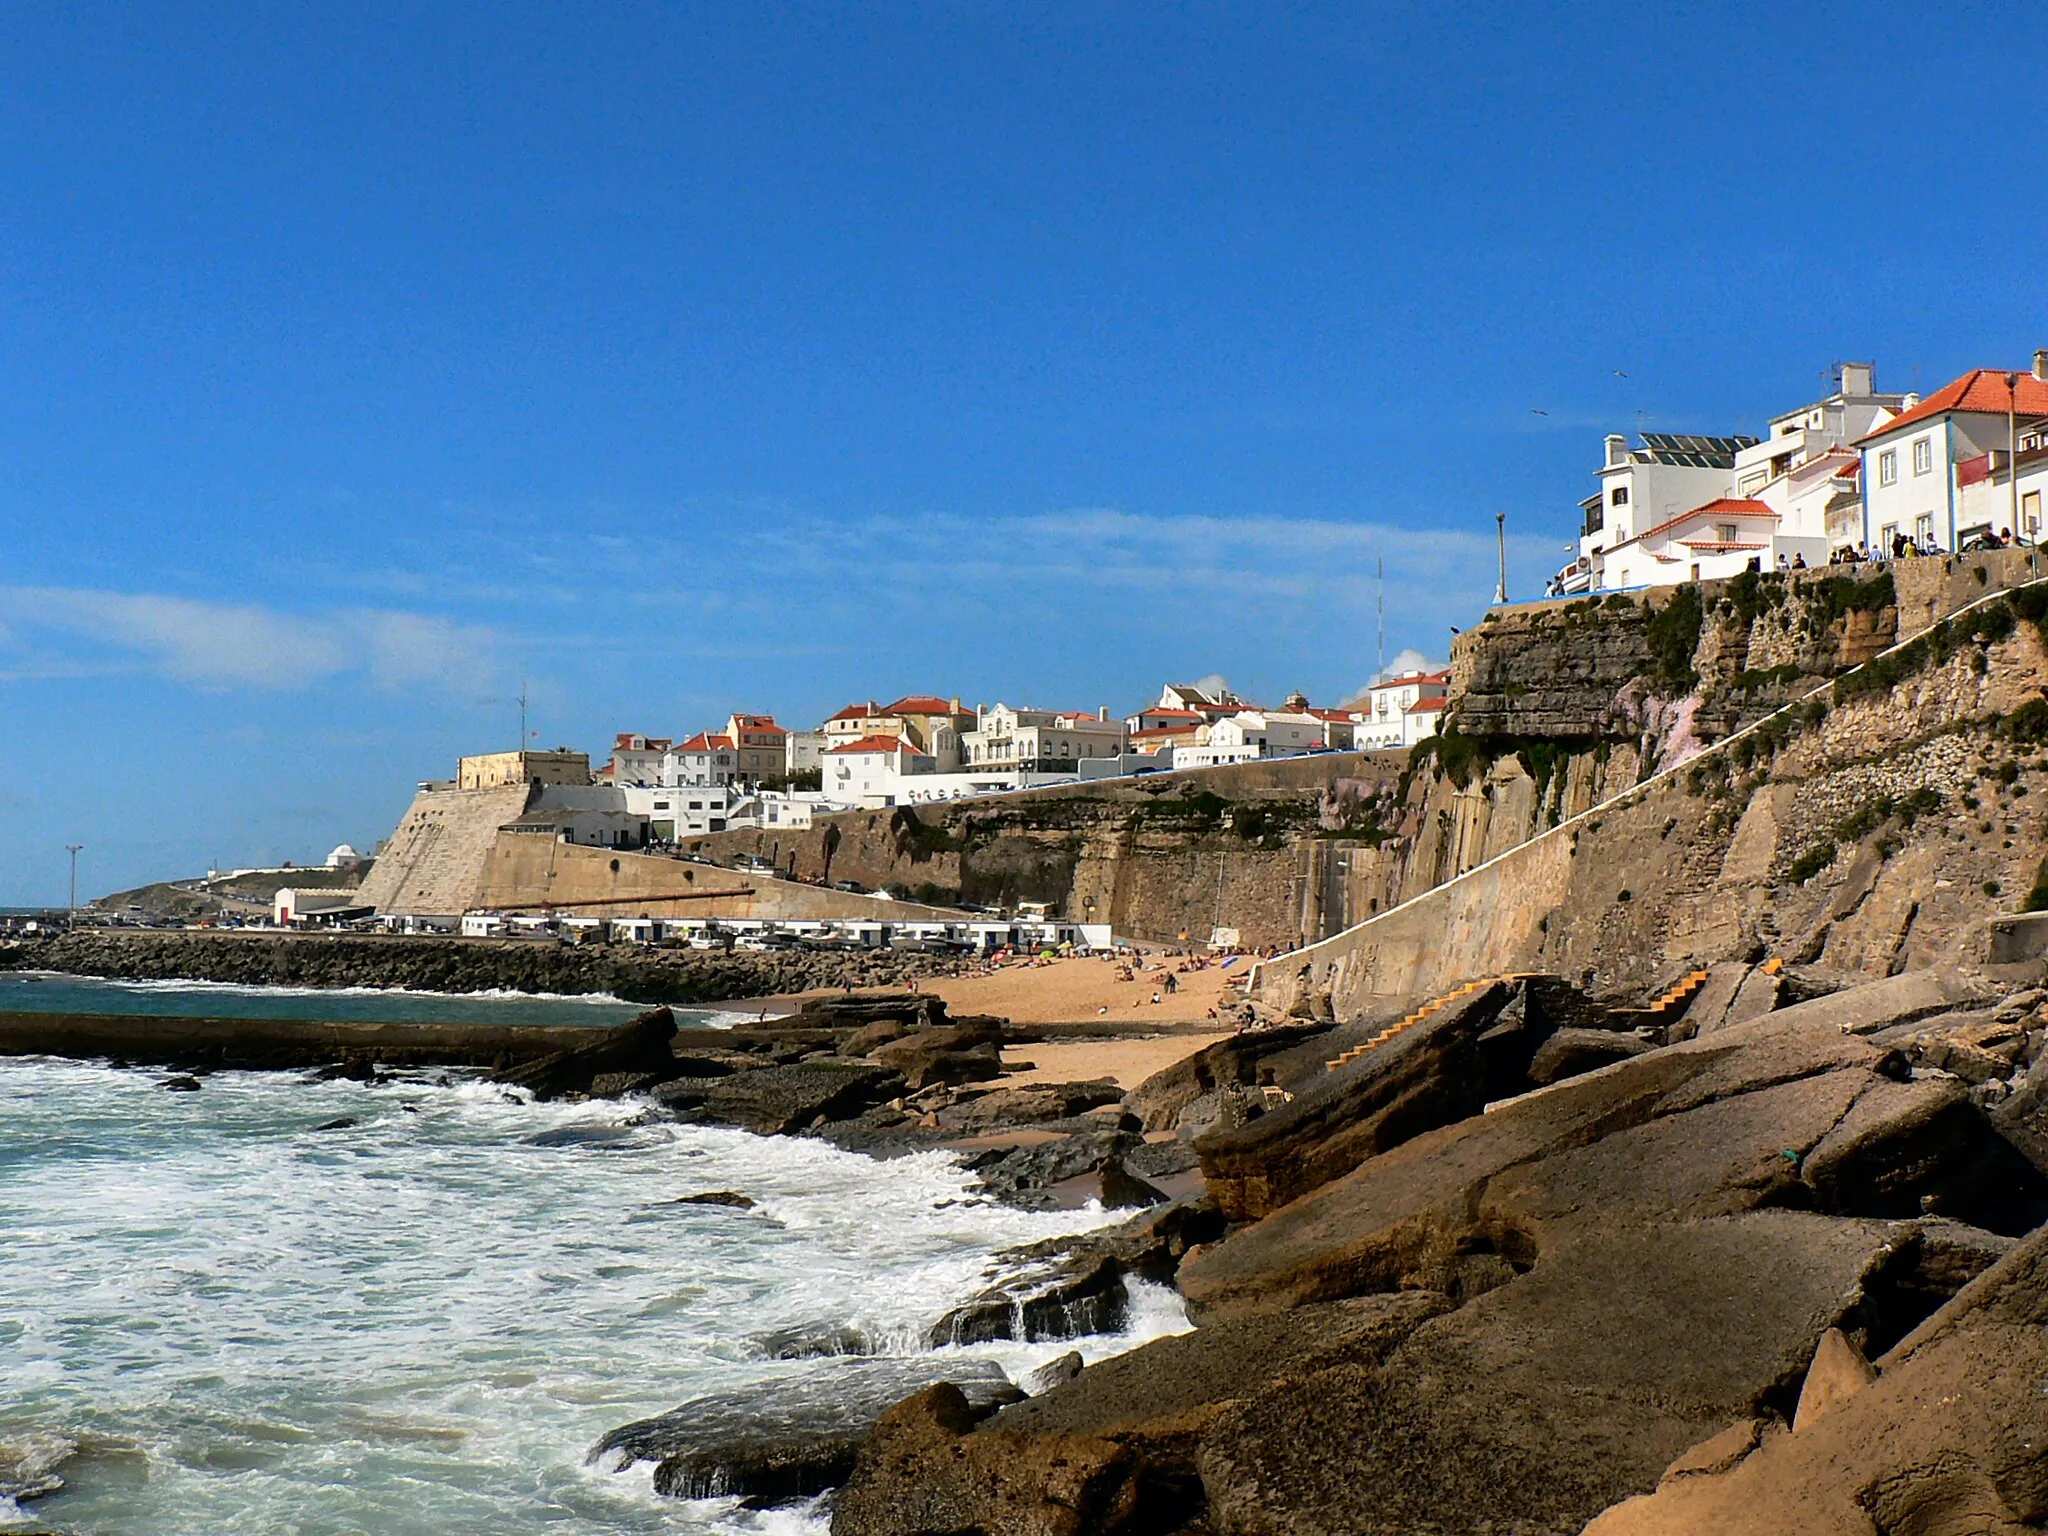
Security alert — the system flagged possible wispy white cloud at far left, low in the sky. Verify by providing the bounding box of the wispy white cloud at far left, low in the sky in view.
[0,588,494,688]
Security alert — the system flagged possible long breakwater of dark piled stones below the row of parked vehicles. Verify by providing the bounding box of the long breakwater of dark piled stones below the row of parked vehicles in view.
[0,928,956,1008]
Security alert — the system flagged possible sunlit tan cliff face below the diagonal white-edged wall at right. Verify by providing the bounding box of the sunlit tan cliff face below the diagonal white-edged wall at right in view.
[1262,561,2048,1016]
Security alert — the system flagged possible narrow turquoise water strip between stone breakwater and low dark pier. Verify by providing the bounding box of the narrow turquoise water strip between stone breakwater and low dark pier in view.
[0,971,647,1024]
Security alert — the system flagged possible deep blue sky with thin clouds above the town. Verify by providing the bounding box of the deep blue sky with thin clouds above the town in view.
[0,4,2048,903]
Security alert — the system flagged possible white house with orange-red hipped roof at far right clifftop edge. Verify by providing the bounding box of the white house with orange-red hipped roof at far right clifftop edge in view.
[1855,350,2048,555]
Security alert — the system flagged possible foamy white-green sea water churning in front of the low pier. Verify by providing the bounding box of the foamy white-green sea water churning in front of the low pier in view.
[0,999,1186,1536]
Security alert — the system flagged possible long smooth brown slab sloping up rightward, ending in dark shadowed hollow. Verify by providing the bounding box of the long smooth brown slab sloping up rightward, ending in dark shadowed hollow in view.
[1180,999,2048,1319]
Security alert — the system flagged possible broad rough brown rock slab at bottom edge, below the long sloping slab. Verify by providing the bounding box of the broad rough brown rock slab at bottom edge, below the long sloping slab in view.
[1198,1210,1896,1536]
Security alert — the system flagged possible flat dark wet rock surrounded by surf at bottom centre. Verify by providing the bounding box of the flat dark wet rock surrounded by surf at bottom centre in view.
[592,1358,1024,1501]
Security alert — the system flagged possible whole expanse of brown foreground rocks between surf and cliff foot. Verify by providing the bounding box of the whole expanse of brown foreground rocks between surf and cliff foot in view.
[557,963,2048,1536]
